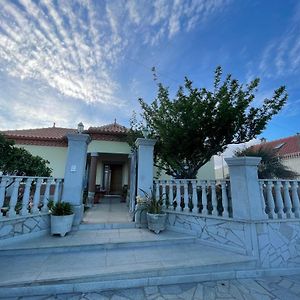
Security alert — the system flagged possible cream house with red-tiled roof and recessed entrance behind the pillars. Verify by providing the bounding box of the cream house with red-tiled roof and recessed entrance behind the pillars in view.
[2,121,215,200]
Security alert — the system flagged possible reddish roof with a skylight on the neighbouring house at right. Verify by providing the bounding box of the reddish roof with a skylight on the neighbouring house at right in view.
[252,134,300,156]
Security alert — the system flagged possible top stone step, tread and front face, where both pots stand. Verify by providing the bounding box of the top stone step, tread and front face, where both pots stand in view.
[0,228,196,256]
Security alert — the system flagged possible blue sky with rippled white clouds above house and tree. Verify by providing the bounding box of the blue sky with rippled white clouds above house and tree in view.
[0,0,300,139]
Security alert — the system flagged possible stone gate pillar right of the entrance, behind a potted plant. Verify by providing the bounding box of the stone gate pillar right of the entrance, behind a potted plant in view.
[135,138,156,227]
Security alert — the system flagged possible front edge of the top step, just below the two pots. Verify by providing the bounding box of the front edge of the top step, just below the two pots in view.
[0,236,198,256]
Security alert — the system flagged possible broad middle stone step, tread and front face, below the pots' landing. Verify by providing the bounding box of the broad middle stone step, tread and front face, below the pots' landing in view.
[0,242,256,298]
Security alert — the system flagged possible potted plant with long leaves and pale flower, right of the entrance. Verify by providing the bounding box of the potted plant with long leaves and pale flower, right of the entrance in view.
[138,191,167,234]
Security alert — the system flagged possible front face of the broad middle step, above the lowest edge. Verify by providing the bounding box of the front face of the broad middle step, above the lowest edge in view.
[0,257,256,295]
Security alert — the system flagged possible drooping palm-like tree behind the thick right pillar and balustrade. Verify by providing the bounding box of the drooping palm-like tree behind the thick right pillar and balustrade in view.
[235,146,299,179]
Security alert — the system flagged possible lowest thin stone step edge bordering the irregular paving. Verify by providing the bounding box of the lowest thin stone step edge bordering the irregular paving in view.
[0,268,300,299]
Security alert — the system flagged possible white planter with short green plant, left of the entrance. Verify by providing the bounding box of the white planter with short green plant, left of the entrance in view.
[50,201,74,236]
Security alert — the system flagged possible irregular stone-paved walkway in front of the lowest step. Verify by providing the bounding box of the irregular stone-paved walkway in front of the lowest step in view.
[10,276,300,300]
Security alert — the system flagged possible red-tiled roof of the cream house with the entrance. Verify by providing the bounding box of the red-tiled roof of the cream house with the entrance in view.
[1,122,128,147]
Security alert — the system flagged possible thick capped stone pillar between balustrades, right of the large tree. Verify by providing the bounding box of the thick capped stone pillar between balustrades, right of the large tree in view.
[225,157,267,220]
